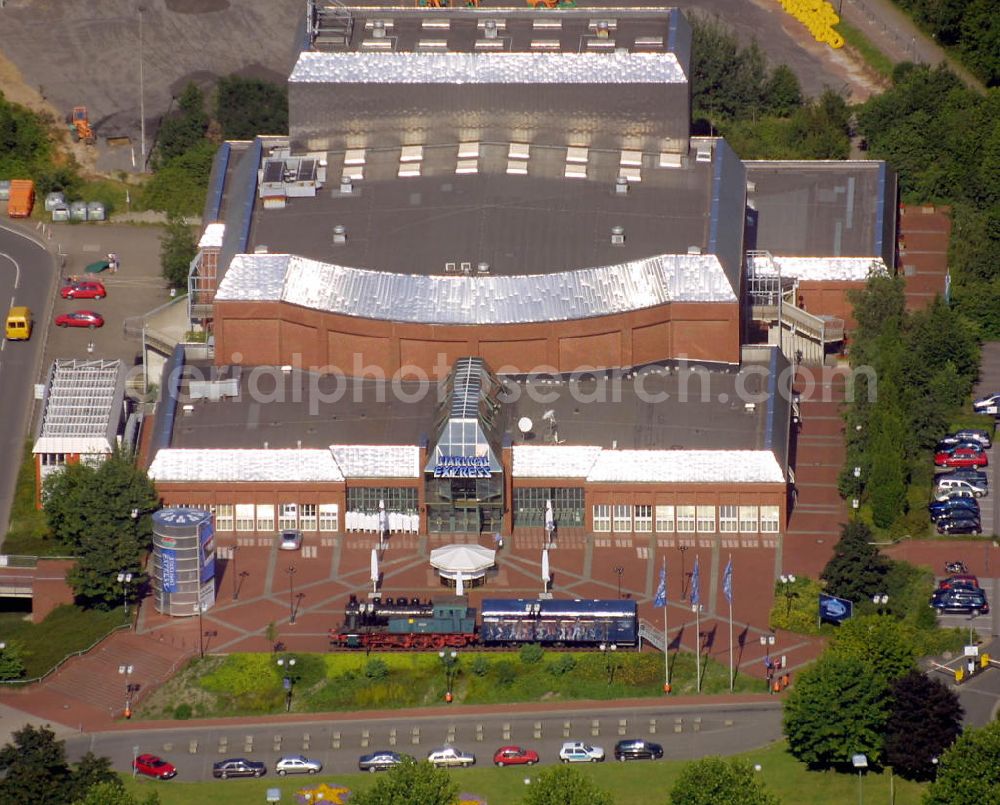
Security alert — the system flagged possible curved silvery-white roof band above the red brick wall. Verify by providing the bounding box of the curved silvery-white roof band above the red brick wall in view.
[215,254,736,324]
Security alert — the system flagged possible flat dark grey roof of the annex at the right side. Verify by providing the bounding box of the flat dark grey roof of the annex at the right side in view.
[745,161,895,257]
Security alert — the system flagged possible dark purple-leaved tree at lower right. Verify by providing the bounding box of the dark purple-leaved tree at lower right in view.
[885,669,963,780]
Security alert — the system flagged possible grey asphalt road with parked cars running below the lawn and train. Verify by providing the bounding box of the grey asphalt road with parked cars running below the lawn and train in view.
[67,701,781,780]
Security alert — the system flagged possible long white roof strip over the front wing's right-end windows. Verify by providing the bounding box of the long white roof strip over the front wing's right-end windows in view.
[587,450,785,484]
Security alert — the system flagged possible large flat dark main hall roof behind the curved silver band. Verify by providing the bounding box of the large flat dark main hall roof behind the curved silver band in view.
[250,148,720,275]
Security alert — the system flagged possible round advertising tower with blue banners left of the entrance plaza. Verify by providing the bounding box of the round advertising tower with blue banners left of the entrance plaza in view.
[152,508,215,616]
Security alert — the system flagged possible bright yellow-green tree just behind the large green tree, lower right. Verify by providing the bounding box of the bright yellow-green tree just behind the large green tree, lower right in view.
[829,615,917,683]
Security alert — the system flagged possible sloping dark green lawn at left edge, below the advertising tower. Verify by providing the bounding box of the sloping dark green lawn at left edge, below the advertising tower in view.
[0,604,126,679]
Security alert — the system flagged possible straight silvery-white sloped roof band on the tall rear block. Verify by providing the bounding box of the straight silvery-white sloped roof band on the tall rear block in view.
[288,51,687,84]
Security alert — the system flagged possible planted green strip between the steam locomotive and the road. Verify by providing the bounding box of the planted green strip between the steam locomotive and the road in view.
[137,651,761,719]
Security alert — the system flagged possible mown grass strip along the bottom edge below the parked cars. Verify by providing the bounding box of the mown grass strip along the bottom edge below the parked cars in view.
[119,743,924,805]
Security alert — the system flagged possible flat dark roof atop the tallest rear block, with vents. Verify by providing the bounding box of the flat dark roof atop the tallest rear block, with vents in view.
[328,4,687,57]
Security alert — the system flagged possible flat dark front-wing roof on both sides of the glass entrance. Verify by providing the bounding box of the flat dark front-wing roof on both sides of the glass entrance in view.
[170,361,787,450]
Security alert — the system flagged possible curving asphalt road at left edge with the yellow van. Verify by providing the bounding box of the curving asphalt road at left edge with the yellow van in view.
[0,224,56,542]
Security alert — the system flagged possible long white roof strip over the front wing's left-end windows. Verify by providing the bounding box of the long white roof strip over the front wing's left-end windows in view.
[149,448,344,483]
